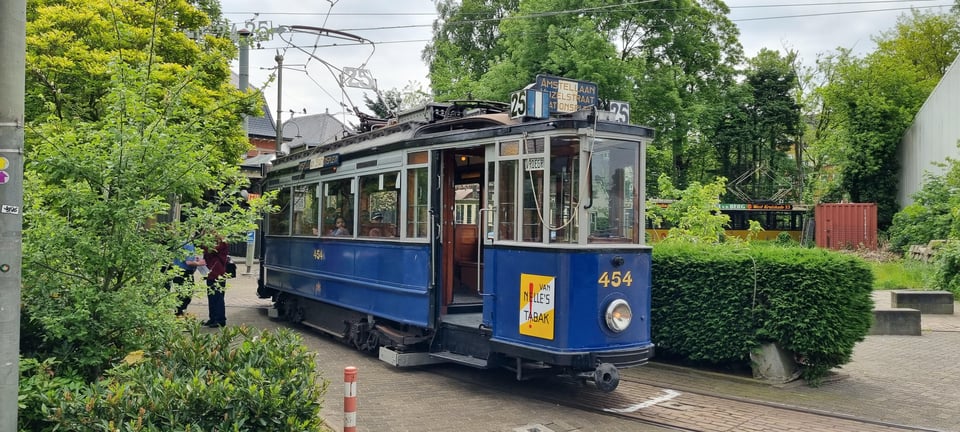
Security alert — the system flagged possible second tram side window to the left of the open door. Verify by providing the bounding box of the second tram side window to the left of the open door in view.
[357,171,400,237]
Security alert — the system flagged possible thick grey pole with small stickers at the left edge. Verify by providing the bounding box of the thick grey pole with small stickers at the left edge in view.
[0,0,27,432]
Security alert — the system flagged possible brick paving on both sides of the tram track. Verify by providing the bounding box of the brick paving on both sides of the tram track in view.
[189,265,960,432]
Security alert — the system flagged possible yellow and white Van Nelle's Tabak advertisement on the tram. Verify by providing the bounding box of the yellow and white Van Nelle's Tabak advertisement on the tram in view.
[520,273,557,340]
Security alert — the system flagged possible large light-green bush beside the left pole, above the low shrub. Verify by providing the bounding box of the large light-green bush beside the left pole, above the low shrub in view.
[22,65,270,378]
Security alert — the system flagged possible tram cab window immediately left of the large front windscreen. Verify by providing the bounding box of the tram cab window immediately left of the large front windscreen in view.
[550,137,580,243]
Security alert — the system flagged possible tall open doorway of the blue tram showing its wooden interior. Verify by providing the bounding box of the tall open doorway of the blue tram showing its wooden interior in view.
[440,147,484,313]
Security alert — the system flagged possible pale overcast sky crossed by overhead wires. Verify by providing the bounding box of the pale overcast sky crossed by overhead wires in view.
[221,0,952,125]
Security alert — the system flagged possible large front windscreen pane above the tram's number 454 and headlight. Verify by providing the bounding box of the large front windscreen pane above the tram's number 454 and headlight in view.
[588,139,640,243]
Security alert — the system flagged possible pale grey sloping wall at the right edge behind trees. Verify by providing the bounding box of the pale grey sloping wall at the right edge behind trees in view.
[897,56,960,207]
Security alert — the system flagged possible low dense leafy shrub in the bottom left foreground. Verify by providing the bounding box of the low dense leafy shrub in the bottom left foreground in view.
[34,324,328,431]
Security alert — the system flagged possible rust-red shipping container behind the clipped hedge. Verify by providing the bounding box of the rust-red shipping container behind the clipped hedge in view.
[814,203,877,250]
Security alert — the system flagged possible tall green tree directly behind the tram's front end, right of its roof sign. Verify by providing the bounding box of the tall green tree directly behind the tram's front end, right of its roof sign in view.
[628,0,743,187]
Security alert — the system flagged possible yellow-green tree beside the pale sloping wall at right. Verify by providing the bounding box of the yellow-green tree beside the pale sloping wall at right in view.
[819,11,960,229]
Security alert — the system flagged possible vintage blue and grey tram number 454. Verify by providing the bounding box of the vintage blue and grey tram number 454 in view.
[258,87,654,391]
